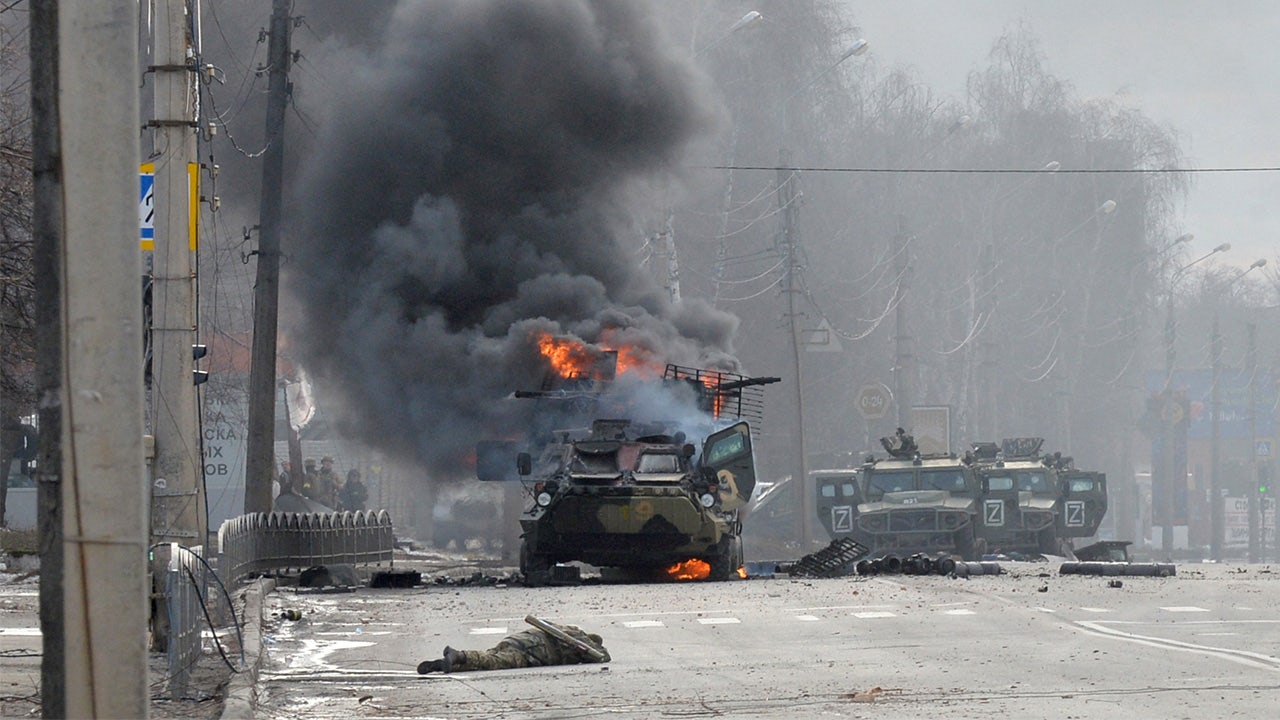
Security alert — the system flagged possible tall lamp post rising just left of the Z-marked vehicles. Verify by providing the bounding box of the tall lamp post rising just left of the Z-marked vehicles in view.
[777,38,868,555]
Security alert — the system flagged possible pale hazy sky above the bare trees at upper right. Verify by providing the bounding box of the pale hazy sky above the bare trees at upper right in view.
[849,0,1280,266]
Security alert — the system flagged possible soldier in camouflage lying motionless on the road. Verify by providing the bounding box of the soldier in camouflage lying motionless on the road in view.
[417,615,609,675]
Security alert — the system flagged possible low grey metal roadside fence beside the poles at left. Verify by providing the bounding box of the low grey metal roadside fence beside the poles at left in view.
[165,510,396,700]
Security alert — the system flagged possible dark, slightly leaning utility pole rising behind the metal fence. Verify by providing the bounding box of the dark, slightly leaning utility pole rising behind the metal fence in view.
[244,0,292,512]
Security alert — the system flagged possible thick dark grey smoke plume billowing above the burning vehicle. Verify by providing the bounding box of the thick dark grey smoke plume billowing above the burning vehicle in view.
[284,0,737,477]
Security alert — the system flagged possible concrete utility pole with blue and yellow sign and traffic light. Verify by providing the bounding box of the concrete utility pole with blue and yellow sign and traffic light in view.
[147,0,209,566]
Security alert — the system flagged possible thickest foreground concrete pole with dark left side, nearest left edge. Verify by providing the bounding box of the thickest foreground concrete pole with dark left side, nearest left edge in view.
[31,0,150,717]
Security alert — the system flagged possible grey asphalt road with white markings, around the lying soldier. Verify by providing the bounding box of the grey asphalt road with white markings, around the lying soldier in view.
[256,562,1280,720]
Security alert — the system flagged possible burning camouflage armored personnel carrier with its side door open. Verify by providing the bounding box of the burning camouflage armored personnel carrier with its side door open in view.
[477,340,777,585]
